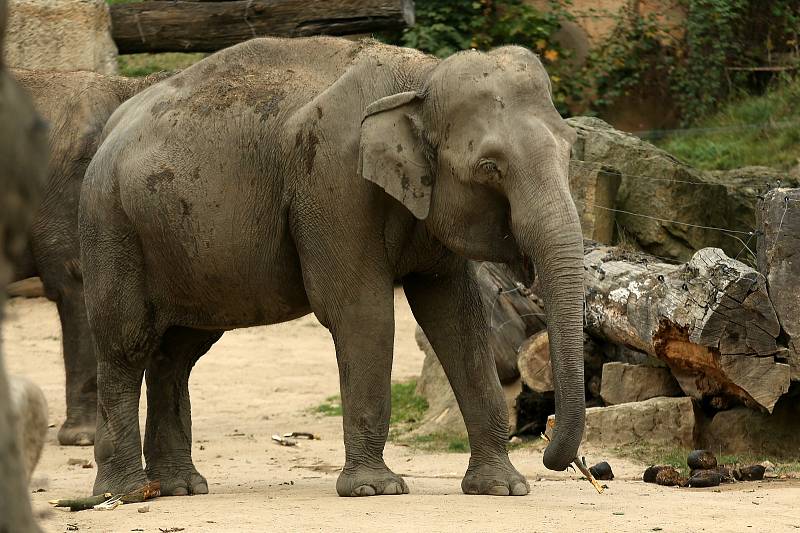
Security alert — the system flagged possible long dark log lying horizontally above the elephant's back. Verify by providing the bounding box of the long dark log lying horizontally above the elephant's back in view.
[111,0,414,54]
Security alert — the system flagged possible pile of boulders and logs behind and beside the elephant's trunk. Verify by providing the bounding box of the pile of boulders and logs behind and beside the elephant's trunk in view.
[416,117,800,456]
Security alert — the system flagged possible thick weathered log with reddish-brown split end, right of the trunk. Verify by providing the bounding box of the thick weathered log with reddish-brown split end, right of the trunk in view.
[584,241,789,412]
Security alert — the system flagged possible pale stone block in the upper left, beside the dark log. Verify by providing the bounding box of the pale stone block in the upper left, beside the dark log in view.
[6,0,117,74]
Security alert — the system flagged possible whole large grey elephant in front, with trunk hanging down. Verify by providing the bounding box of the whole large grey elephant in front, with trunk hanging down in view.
[80,38,584,496]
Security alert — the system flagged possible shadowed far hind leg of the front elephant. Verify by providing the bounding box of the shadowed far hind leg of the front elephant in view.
[144,327,222,496]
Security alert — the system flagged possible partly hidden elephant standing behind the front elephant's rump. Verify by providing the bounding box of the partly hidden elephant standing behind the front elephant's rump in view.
[14,70,171,446]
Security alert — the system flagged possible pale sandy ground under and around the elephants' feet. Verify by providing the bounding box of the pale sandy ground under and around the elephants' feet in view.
[2,292,800,533]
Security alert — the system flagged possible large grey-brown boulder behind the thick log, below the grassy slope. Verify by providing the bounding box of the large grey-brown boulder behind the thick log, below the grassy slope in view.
[567,117,788,261]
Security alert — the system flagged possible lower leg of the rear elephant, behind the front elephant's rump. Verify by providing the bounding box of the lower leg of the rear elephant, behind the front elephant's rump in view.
[52,280,97,446]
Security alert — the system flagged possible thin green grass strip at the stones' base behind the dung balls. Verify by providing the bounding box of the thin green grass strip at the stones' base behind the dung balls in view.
[614,443,800,476]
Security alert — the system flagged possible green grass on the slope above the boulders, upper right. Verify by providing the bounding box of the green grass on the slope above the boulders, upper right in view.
[657,76,800,170]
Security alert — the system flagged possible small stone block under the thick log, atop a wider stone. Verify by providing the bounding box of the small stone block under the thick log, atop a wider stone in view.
[600,362,683,405]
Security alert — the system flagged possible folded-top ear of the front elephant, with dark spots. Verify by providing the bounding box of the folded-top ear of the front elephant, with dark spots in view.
[358,92,433,220]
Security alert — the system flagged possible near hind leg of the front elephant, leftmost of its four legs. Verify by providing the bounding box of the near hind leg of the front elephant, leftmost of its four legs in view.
[80,182,158,494]
